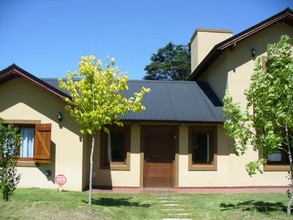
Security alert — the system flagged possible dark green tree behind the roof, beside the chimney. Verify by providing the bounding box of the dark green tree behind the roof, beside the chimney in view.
[143,42,191,80]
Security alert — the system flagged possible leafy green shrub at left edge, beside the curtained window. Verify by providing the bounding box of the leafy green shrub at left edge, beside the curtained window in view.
[0,118,21,201]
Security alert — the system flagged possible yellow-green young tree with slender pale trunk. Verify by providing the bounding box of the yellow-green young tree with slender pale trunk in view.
[59,56,150,204]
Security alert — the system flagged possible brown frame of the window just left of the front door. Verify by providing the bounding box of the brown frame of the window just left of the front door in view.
[100,124,131,171]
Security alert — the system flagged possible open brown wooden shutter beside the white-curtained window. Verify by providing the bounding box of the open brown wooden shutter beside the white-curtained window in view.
[34,124,51,163]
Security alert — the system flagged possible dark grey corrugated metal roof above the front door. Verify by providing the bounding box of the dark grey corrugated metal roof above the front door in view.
[43,79,224,122]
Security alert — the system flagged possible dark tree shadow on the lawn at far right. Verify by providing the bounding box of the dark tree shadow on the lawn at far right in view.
[220,200,286,214]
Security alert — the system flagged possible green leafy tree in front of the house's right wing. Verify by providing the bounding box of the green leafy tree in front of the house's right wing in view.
[224,36,293,214]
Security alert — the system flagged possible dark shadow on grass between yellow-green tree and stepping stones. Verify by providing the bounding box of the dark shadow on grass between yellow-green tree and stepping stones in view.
[83,198,151,208]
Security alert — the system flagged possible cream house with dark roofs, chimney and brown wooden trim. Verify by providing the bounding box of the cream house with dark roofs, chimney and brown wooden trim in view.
[0,9,293,191]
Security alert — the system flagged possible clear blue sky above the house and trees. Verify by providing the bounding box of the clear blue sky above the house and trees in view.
[0,0,293,80]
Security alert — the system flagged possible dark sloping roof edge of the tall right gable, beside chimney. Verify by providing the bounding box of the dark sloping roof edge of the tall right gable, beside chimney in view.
[188,8,293,80]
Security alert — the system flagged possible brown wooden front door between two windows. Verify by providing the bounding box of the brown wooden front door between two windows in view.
[143,127,176,187]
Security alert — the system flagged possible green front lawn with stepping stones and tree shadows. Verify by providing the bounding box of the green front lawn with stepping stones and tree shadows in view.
[0,189,293,220]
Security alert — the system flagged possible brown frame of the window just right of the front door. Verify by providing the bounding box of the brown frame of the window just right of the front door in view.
[188,126,217,171]
